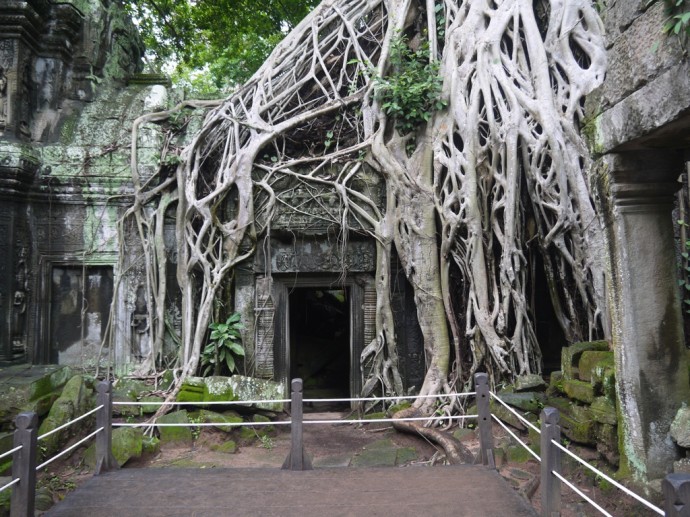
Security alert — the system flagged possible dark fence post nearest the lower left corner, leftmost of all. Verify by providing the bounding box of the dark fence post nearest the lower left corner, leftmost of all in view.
[10,412,38,517]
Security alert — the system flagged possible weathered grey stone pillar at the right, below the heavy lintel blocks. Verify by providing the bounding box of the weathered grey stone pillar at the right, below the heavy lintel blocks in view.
[603,150,690,481]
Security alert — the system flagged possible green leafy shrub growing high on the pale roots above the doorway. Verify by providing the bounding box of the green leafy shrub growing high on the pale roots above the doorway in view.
[374,35,448,133]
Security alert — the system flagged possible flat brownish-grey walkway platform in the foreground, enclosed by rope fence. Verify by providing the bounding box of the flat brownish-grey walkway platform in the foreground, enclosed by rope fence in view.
[46,465,537,517]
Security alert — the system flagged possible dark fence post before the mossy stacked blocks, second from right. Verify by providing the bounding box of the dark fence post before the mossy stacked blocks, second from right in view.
[540,407,561,517]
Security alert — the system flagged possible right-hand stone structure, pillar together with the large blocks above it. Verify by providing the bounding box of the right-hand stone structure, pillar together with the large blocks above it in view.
[584,0,690,481]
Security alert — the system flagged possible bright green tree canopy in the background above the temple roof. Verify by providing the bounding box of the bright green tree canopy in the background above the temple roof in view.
[124,0,318,90]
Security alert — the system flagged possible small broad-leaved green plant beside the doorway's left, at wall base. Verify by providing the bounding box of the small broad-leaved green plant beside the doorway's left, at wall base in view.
[201,312,244,375]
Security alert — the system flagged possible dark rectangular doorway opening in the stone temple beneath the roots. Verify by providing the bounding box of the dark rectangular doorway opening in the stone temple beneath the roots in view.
[289,287,351,411]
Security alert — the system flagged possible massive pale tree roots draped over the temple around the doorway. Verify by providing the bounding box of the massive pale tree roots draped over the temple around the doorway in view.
[121,0,605,412]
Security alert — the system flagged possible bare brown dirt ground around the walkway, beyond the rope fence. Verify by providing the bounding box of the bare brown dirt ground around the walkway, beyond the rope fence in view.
[39,413,661,517]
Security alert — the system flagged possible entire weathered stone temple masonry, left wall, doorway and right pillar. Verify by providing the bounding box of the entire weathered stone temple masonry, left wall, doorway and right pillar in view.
[0,0,690,484]
